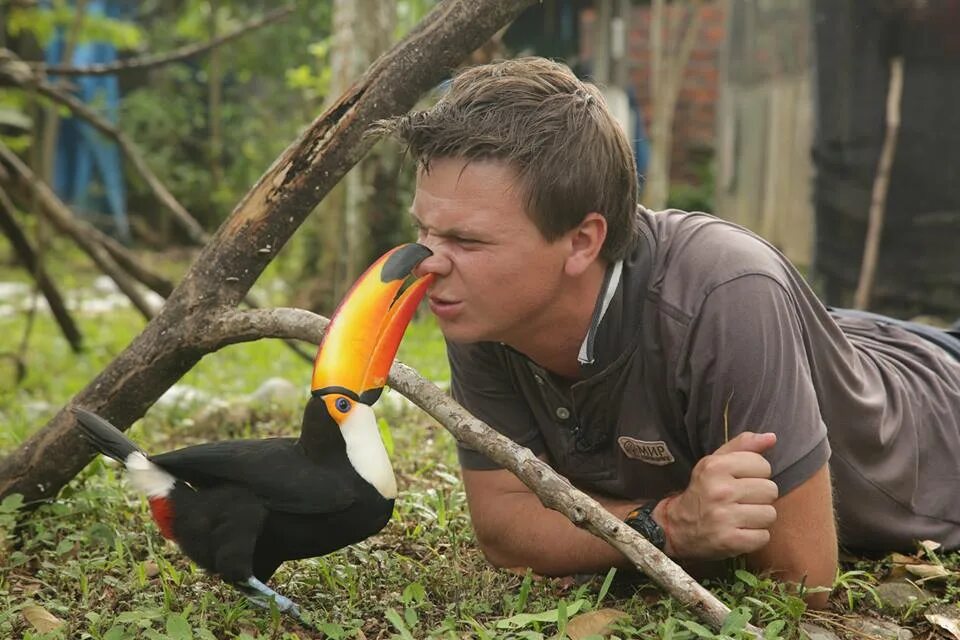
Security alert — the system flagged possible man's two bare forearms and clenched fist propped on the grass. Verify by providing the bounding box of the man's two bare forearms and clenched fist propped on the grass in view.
[463,433,837,607]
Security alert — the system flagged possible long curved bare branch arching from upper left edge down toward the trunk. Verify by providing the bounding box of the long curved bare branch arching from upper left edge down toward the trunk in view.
[0,49,210,245]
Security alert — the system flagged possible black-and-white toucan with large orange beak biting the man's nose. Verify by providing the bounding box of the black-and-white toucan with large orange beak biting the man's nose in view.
[74,243,432,622]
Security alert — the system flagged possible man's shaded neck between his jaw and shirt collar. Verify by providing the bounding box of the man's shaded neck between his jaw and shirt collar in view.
[508,261,606,380]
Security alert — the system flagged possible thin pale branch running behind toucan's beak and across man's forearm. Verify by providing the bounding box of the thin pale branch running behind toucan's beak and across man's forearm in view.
[189,309,761,638]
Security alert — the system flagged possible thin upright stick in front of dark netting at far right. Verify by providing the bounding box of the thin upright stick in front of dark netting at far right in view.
[853,56,903,309]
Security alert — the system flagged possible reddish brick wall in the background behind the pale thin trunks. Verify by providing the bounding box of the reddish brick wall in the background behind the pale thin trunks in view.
[581,0,725,182]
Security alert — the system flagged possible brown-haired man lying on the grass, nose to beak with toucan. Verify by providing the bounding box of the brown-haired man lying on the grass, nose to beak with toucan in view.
[374,58,960,604]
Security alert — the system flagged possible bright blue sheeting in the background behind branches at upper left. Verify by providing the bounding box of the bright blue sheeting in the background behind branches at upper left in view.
[42,0,130,242]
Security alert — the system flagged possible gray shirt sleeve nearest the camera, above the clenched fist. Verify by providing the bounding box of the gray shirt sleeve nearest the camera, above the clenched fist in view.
[685,274,830,496]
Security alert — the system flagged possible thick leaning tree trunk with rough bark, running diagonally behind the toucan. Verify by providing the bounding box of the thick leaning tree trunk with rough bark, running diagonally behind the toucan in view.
[0,0,533,501]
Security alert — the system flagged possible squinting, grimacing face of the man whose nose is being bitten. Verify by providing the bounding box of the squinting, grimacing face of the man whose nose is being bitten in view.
[411,158,569,349]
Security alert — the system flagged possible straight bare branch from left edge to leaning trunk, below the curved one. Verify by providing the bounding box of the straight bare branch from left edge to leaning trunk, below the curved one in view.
[0,143,156,320]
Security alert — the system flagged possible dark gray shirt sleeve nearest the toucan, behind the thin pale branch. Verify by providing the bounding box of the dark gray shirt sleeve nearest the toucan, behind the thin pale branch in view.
[447,341,546,470]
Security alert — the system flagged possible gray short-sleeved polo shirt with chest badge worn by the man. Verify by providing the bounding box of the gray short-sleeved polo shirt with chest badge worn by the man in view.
[448,208,960,549]
